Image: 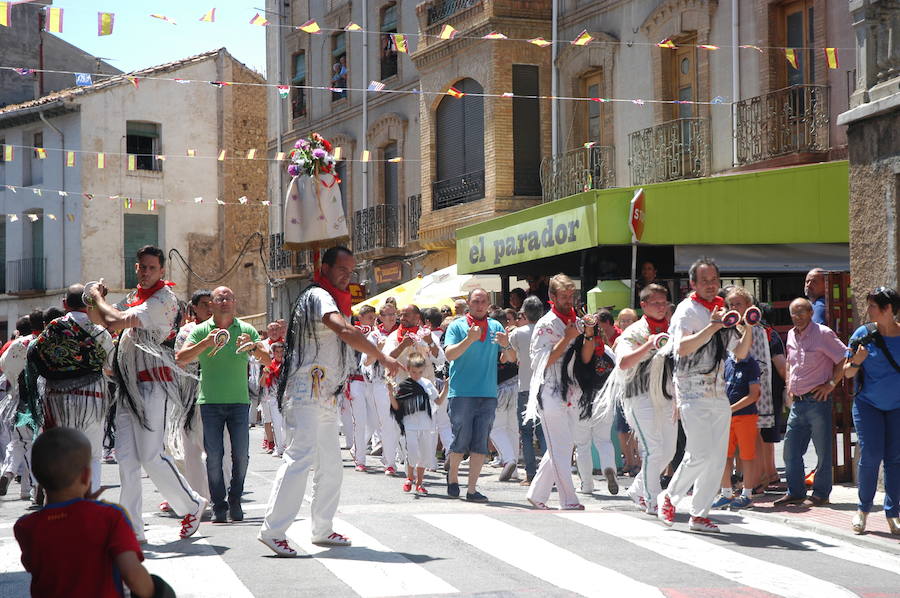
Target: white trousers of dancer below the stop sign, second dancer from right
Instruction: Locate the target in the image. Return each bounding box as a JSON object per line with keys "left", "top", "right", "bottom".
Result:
{"left": 625, "top": 395, "right": 678, "bottom": 512}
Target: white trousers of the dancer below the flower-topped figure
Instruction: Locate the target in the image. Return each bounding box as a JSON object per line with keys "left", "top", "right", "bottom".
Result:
{"left": 260, "top": 400, "right": 344, "bottom": 540}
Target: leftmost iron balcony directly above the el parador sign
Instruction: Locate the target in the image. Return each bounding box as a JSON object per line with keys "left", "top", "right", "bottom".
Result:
{"left": 541, "top": 145, "right": 616, "bottom": 202}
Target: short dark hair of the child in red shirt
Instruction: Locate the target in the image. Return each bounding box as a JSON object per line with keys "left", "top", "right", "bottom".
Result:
{"left": 31, "top": 428, "right": 91, "bottom": 492}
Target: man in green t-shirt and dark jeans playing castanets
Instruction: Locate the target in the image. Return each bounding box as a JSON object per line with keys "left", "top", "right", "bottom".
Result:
{"left": 176, "top": 287, "right": 271, "bottom": 523}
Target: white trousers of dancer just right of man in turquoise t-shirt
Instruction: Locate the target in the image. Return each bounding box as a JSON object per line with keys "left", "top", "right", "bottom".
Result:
{"left": 527, "top": 396, "right": 578, "bottom": 505}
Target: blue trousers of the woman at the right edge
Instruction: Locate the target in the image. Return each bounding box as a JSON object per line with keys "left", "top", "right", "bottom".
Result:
{"left": 853, "top": 400, "right": 900, "bottom": 517}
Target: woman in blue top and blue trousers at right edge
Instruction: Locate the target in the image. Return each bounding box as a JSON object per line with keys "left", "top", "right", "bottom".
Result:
{"left": 844, "top": 287, "right": 900, "bottom": 535}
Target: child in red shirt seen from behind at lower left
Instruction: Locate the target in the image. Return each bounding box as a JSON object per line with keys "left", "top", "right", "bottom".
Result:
{"left": 14, "top": 428, "right": 162, "bottom": 598}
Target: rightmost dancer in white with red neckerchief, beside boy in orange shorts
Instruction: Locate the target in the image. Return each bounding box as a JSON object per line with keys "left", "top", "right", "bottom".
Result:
{"left": 657, "top": 258, "right": 753, "bottom": 532}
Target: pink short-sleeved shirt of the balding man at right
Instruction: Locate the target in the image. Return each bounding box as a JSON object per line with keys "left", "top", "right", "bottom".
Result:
{"left": 786, "top": 322, "right": 847, "bottom": 396}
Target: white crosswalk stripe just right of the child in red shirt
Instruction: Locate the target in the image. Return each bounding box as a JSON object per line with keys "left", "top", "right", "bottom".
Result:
{"left": 143, "top": 526, "right": 253, "bottom": 598}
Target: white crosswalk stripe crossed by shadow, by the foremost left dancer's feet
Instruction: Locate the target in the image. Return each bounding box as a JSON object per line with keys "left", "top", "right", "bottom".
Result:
{"left": 288, "top": 519, "right": 459, "bottom": 598}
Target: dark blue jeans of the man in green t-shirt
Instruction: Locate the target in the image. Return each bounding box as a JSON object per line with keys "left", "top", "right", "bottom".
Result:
{"left": 200, "top": 403, "right": 250, "bottom": 514}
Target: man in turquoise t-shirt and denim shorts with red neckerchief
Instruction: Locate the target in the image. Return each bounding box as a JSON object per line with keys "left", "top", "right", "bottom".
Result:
{"left": 444, "top": 289, "right": 512, "bottom": 502}
